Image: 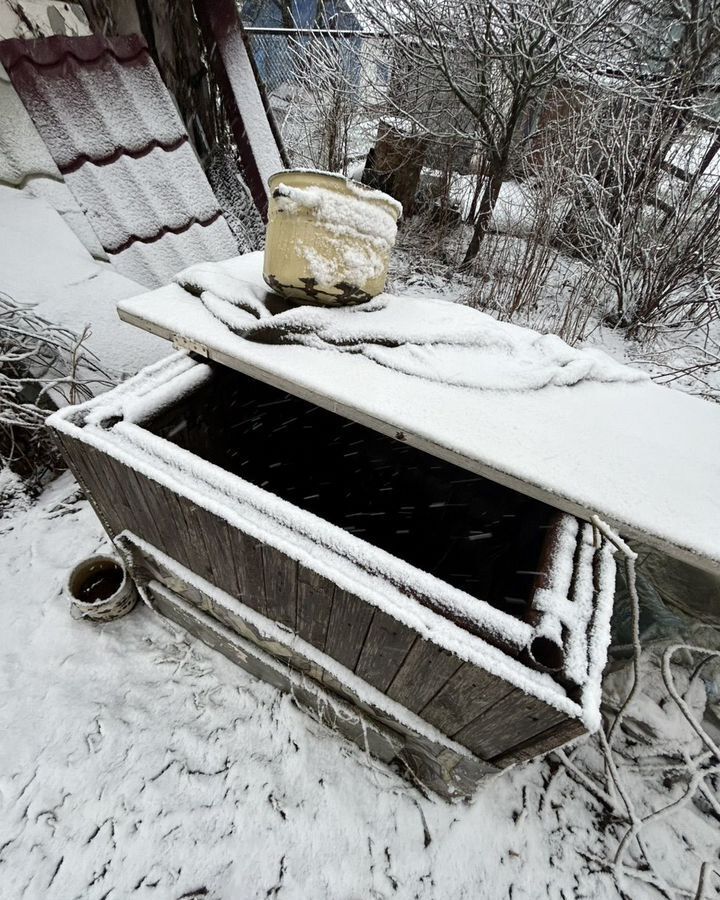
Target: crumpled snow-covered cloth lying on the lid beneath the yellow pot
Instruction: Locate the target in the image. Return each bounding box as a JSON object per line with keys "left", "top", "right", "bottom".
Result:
{"left": 175, "top": 256, "right": 648, "bottom": 391}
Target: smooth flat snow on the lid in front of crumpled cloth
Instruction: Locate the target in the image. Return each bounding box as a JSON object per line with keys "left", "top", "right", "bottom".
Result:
{"left": 118, "top": 253, "right": 720, "bottom": 571}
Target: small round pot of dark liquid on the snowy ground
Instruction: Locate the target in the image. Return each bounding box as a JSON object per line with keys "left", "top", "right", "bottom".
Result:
{"left": 65, "top": 556, "right": 138, "bottom": 622}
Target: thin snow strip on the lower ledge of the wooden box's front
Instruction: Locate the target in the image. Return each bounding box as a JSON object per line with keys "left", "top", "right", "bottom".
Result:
{"left": 125, "top": 531, "right": 496, "bottom": 765}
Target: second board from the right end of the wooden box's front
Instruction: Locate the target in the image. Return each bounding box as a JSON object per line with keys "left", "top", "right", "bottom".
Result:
{"left": 453, "top": 689, "right": 568, "bottom": 759}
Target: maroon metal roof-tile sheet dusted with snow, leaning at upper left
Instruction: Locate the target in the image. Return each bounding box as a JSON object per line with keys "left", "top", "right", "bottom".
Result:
{"left": 0, "top": 35, "right": 237, "bottom": 286}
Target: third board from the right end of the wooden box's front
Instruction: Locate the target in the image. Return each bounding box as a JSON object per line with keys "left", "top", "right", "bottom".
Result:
{"left": 420, "top": 663, "right": 512, "bottom": 736}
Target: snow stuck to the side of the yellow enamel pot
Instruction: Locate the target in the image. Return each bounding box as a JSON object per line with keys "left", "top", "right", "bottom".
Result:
{"left": 273, "top": 182, "right": 398, "bottom": 287}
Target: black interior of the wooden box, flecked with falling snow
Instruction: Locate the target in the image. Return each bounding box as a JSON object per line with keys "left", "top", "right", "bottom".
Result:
{"left": 144, "top": 367, "right": 555, "bottom": 617}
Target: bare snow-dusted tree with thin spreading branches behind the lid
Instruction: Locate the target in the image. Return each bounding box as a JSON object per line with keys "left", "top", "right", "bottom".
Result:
{"left": 372, "top": 0, "right": 618, "bottom": 265}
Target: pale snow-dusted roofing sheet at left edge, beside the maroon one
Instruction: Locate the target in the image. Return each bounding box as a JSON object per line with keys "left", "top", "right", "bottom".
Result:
{"left": 0, "top": 66, "right": 107, "bottom": 259}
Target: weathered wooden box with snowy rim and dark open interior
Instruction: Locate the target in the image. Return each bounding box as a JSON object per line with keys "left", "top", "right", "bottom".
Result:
{"left": 50, "top": 353, "right": 614, "bottom": 798}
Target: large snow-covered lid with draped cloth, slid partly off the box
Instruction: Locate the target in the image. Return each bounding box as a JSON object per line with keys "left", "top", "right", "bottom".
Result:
{"left": 118, "top": 253, "right": 720, "bottom": 571}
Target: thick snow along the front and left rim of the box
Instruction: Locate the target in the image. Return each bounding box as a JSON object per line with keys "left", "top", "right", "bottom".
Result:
{"left": 49, "top": 353, "right": 612, "bottom": 728}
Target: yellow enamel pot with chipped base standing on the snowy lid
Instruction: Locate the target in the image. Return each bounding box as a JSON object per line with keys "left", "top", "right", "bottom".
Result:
{"left": 263, "top": 170, "right": 402, "bottom": 306}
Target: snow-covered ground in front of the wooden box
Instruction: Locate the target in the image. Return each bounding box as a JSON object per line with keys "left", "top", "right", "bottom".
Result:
{"left": 0, "top": 475, "right": 720, "bottom": 900}
